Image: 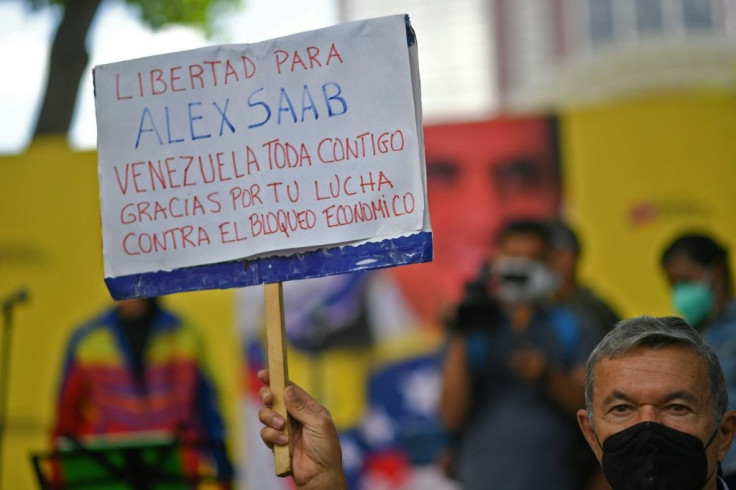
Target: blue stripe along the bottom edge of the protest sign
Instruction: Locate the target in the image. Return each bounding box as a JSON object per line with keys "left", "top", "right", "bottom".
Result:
{"left": 105, "top": 231, "right": 432, "bottom": 300}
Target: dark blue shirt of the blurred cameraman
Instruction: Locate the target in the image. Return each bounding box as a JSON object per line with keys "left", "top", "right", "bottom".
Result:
{"left": 457, "top": 308, "right": 599, "bottom": 490}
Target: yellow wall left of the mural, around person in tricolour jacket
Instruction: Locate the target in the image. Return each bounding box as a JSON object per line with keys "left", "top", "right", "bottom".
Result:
{"left": 0, "top": 138, "right": 240, "bottom": 489}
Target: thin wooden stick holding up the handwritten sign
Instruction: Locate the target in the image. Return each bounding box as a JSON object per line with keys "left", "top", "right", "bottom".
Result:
{"left": 264, "top": 282, "right": 291, "bottom": 476}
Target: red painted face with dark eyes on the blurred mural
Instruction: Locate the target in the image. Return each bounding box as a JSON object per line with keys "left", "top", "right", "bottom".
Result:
{"left": 393, "top": 118, "right": 560, "bottom": 323}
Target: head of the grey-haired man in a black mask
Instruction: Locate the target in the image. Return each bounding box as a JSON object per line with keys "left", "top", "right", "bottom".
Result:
{"left": 578, "top": 316, "right": 736, "bottom": 490}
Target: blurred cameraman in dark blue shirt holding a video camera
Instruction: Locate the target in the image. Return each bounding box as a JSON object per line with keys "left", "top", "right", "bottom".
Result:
{"left": 440, "top": 221, "right": 600, "bottom": 490}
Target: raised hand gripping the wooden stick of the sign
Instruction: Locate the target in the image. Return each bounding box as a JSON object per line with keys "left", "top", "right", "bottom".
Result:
{"left": 258, "top": 369, "right": 347, "bottom": 490}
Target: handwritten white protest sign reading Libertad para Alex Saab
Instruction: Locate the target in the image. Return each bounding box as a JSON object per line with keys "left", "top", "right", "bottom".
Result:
{"left": 94, "top": 16, "right": 431, "bottom": 299}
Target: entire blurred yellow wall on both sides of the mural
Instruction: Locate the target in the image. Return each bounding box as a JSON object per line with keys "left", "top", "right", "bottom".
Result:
{"left": 5, "top": 93, "right": 736, "bottom": 489}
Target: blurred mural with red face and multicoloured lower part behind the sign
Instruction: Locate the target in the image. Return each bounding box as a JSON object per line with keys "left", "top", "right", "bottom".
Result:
{"left": 244, "top": 116, "right": 560, "bottom": 490}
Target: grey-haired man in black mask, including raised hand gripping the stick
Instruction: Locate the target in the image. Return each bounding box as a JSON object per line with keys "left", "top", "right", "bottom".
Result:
{"left": 259, "top": 317, "right": 736, "bottom": 490}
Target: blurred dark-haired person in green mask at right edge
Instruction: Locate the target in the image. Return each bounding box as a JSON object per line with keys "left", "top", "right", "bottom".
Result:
{"left": 662, "top": 233, "right": 736, "bottom": 487}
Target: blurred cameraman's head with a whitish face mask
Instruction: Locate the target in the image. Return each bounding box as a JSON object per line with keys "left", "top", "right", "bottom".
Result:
{"left": 490, "top": 220, "right": 557, "bottom": 303}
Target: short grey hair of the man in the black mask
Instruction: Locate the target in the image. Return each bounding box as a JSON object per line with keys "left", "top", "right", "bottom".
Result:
{"left": 585, "top": 316, "right": 728, "bottom": 422}
